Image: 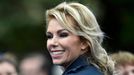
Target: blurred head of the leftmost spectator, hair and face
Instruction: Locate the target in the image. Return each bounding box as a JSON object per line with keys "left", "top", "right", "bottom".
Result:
{"left": 0, "top": 53, "right": 18, "bottom": 75}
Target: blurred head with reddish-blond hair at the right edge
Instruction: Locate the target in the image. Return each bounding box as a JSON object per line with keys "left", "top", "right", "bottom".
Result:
{"left": 111, "top": 51, "right": 134, "bottom": 75}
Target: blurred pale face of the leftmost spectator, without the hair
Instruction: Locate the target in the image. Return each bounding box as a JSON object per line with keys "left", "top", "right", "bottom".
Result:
{"left": 0, "top": 62, "right": 17, "bottom": 75}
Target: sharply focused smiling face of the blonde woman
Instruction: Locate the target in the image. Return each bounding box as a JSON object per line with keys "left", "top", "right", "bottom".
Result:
{"left": 46, "top": 19, "right": 85, "bottom": 67}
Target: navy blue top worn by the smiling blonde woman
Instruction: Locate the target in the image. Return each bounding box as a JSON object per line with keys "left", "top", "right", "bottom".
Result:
{"left": 62, "top": 56, "right": 103, "bottom": 75}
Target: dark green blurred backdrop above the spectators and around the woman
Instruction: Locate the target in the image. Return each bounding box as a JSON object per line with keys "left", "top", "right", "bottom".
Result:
{"left": 0, "top": 0, "right": 134, "bottom": 56}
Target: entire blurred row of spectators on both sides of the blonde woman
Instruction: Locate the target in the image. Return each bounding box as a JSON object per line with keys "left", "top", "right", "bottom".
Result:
{"left": 0, "top": 51, "right": 134, "bottom": 75}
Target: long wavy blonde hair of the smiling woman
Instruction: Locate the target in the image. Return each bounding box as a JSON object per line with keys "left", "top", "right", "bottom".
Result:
{"left": 46, "top": 2, "right": 114, "bottom": 75}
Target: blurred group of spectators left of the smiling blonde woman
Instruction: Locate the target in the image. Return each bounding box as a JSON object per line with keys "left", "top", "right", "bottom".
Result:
{"left": 0, "top": 52, "right": 62, "bottom": 75}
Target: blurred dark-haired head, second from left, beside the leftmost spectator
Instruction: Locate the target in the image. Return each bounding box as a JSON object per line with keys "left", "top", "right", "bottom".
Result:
{"left": 19, "top": 52, "right": 52, "bottom": 75}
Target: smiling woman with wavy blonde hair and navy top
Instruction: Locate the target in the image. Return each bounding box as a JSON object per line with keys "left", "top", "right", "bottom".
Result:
{"left": 46, "top": 2, "right": 114, "bottom": 75}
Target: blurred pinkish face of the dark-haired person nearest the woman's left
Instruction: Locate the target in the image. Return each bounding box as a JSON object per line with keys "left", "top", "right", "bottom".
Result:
{"left": 20, "top": 58, "right": 48, "bottom": 75}
